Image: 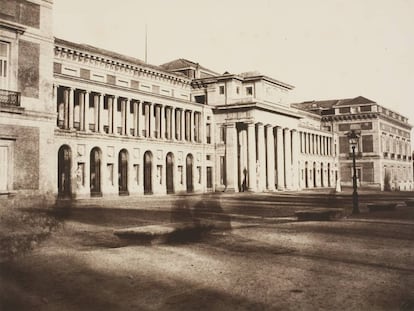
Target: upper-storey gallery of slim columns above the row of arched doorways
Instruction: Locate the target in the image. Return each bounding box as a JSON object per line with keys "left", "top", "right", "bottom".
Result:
{"left": 54, "top": 86, "right": 206, "bottom": 143}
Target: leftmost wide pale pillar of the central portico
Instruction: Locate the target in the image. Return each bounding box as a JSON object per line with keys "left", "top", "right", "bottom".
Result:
{"left": 226, "top": 123, "right": 238, "bottom": 192}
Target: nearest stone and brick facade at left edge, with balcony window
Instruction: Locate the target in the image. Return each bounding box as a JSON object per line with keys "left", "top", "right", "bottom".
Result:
{"left": 0, "top": 0, "right": 56, "bottom": 206}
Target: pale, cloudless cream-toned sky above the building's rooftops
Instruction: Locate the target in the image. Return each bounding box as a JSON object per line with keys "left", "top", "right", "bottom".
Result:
{"left": 54, "top": 0, "right": 414, "bottom": 146}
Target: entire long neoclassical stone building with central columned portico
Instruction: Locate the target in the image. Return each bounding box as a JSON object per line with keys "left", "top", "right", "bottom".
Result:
{"left": 0, "top": 0, "right": 412, "bottom": 210}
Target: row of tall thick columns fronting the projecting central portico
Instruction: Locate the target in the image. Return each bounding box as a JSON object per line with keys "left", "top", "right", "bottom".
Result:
{"left": 225, "top": 122, "right": 299, "bottom": 192}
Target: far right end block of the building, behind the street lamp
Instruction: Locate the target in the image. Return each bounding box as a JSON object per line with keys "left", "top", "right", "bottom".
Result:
{"left": 292, "top": 96, "right": 414, "bottom": 191}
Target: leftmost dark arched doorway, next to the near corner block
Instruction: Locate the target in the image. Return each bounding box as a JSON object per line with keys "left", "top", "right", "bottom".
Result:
{"left": 58, "top": 146, "right": 72, "bottom": 198}
